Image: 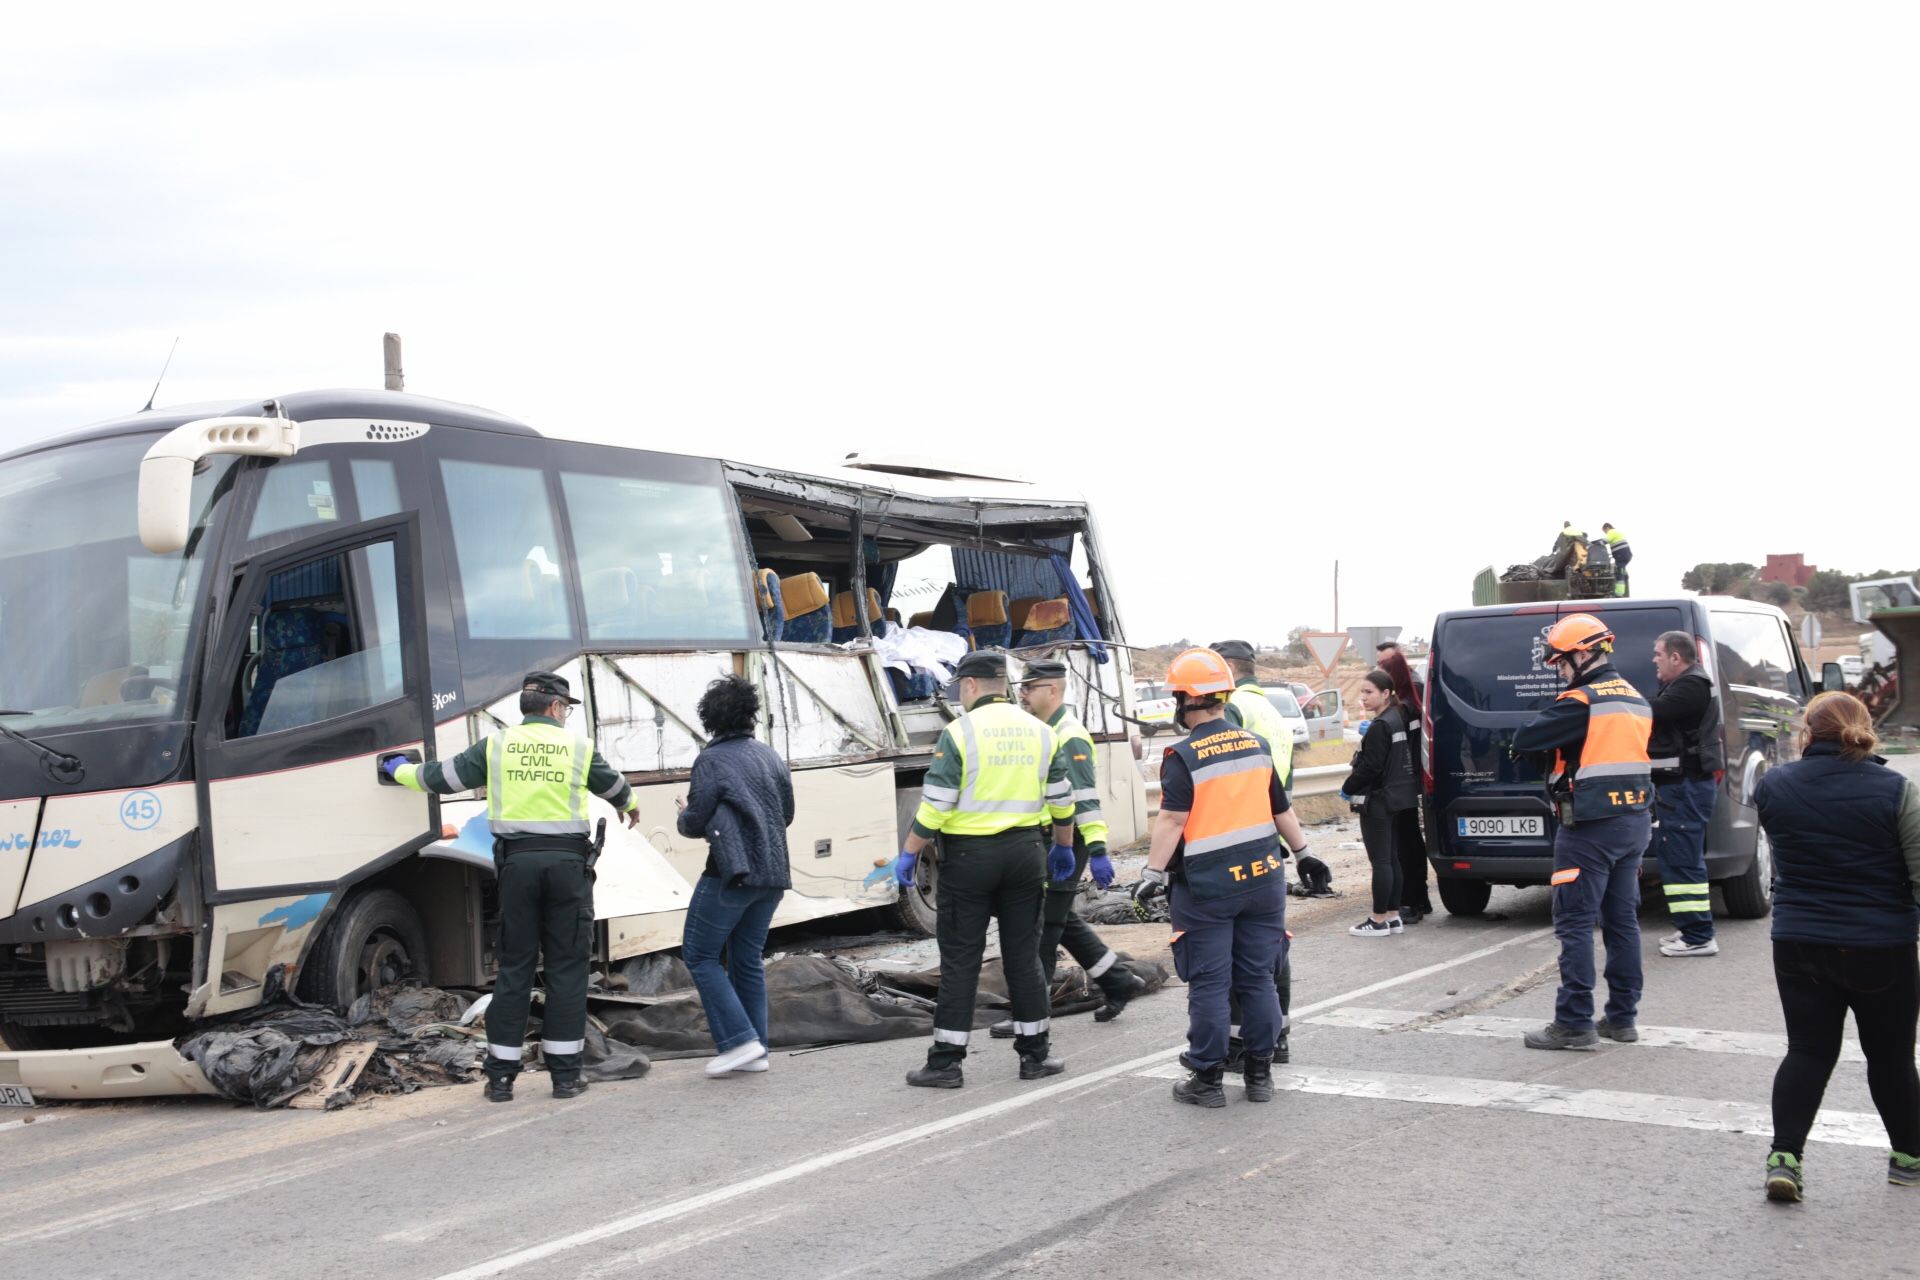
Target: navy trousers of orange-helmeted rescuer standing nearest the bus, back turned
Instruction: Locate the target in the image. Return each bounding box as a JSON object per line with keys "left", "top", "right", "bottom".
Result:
{"left": 1169, "top": 875, "right": 1286, "bottom": 1071}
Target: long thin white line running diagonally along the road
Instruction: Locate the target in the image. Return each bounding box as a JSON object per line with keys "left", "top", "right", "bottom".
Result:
{"left": 438, "top": 929, "right": 1553, "bottom": 1280}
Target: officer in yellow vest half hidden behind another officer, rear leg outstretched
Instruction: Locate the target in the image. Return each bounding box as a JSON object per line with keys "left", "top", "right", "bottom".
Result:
{"left": 983, "top": 658, "right": 1146, "bottom": 1040}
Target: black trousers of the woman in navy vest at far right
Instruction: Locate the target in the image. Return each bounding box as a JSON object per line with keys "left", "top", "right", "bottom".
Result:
{"left": 1774, "top": 940, "right": 1920, "bottom": 1157}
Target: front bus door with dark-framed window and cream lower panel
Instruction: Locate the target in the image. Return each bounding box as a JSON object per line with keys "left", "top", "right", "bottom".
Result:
{"left": 188, "top": 514, "right": 440, "bottom": 1015}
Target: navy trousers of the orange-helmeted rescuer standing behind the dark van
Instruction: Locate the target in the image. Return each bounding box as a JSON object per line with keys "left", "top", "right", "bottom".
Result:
{"left": 1553, "top": 814, "right": 1653, "bottom": 1031}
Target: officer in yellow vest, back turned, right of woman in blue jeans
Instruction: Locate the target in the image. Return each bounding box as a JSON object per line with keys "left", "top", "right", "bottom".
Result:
{"left": 893, "top": 651, "right": 1075, "bottom": 1088}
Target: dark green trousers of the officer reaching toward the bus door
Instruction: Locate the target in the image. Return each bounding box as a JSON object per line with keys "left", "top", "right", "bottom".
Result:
{"left": 486, "top": 841, "right": 593, "bottom": 1082}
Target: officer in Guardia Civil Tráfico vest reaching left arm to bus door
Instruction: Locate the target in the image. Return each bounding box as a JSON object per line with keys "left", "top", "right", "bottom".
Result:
{"left": 380, "top": 672, "right": 639, "bottom": 1102}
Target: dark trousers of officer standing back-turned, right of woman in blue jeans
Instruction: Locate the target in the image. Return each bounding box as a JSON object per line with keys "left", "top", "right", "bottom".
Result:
{"left": 927, "top": 827, "right": 1050, "bottom": 1067}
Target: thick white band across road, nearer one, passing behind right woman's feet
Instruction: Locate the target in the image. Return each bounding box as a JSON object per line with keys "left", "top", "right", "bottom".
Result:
{"left": 1140, "top": 1063, "right": 1887, "bottom": 1150}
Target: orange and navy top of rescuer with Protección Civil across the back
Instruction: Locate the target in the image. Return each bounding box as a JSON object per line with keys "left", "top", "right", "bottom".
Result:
{"left": 1160, "top": 720, "right": 1290, "bottom": 898}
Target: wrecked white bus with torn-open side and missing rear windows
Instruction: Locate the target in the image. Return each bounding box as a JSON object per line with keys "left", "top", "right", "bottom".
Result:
{"left": 0, "top": 391, "right": 1146, "bottom": 1098}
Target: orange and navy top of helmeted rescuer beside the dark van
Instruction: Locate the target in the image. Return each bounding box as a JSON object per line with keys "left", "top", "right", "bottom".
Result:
{"left": 1513, "top": 662, "right": 1653, "bottom": 821}
